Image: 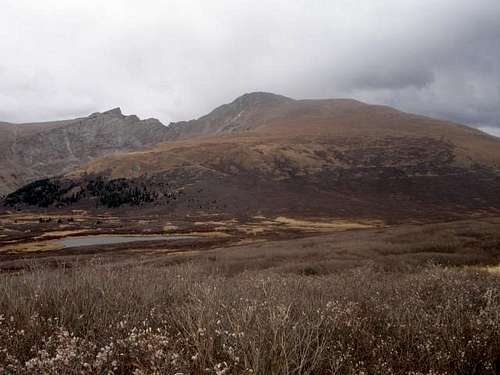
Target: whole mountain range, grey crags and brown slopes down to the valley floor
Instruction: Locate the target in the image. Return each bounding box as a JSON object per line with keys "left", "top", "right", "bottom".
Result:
{"left": 0, "top": 93, "right": 500, "bottom": 218}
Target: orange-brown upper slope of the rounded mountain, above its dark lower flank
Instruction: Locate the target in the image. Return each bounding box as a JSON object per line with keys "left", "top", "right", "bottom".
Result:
{"left": 74, "top": 93, "right": 500, "bottom": 178}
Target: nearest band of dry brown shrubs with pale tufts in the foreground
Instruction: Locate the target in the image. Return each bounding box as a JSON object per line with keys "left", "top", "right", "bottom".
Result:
{"left": 0, "top": 260, "right": 500, "bottom": 375}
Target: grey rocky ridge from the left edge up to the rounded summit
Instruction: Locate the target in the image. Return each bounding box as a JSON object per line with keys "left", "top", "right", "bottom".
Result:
{"left": 0, "top": 93, "right": 292, "bottom": 195}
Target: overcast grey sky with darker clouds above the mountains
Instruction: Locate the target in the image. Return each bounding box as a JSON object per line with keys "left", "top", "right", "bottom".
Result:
{"left": 0, "top": 0, "right": 500, "bottom": 135}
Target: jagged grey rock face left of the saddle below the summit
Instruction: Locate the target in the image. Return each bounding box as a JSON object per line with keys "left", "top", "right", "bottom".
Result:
{"left": 0, "top": 108, "right": 169, "bottom": 194}
